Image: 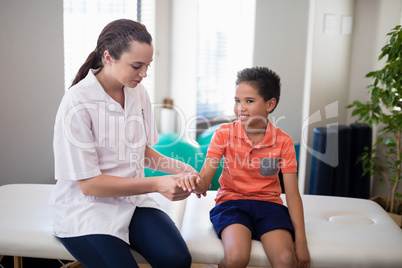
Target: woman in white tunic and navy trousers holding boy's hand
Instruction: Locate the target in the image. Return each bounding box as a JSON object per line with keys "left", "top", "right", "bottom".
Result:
{"left": 50, "top": 20, "right": 198, "bottom": 268}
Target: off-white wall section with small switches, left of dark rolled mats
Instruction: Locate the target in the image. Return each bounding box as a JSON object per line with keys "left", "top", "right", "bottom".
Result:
{"left": 299, "top": 0, "right": 354, "bottom": 192}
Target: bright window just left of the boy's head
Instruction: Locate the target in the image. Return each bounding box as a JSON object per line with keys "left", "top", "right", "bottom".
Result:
{"left": 196, "top": 0, "right": 255, "bottom": 118}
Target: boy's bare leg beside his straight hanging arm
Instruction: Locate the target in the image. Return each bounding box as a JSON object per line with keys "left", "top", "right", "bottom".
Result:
{"left": 260, "top": 229, "right": 297, "bottom": 267}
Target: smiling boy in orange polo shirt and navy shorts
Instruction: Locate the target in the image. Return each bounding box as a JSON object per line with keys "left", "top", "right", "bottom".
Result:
{"left": 179, "top": 67, "right": 310, "bottom": 268}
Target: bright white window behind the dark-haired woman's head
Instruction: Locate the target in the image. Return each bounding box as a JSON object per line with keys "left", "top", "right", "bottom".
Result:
{"left": 63, "top": 0, "right": 155, "bottom": 101}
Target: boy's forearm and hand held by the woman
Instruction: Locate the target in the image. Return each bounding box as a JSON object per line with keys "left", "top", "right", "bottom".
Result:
{"left": 178, "top": 157, "right": 220, "bottom": 196}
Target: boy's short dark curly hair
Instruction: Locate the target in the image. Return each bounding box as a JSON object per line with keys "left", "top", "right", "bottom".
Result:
{"left": 236, "top": 67, "right": 281, "bottom": 111}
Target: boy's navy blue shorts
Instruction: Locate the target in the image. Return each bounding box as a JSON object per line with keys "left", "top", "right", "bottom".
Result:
{"left": 209, "top": 200, "right": 295, "bottom": 241}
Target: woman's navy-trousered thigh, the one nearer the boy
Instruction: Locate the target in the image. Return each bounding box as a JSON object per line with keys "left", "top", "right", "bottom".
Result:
{"left": 129, "top": 207, "right": 191, "bottom": 268}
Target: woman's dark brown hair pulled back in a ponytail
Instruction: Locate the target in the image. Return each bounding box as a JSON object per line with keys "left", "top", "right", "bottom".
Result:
{"left": 71, "top": 19, "right": 152, "bottom": 86}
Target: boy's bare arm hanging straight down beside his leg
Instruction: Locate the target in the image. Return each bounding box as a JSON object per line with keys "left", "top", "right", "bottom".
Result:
{"left": 283, "top": 173, "right": 310, "bottom": 267}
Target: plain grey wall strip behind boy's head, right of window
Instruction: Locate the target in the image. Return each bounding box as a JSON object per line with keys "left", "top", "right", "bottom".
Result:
{"left": 253, "top": 0, "right": 309, "bottom": 143}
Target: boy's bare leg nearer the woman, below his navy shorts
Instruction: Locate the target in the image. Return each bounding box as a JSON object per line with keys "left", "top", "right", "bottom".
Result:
{"left": 219, "top": 223, "right": 251, "bottom": 268}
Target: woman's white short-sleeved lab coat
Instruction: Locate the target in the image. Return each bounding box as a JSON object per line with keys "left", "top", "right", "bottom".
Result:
{"left": 49, "top": 70, "right": 159, "bottom": 243}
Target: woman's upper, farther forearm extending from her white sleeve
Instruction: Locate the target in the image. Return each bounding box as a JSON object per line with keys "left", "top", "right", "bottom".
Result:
{"left": 144, "top": 146, "right": 198, "bottom": 174}
